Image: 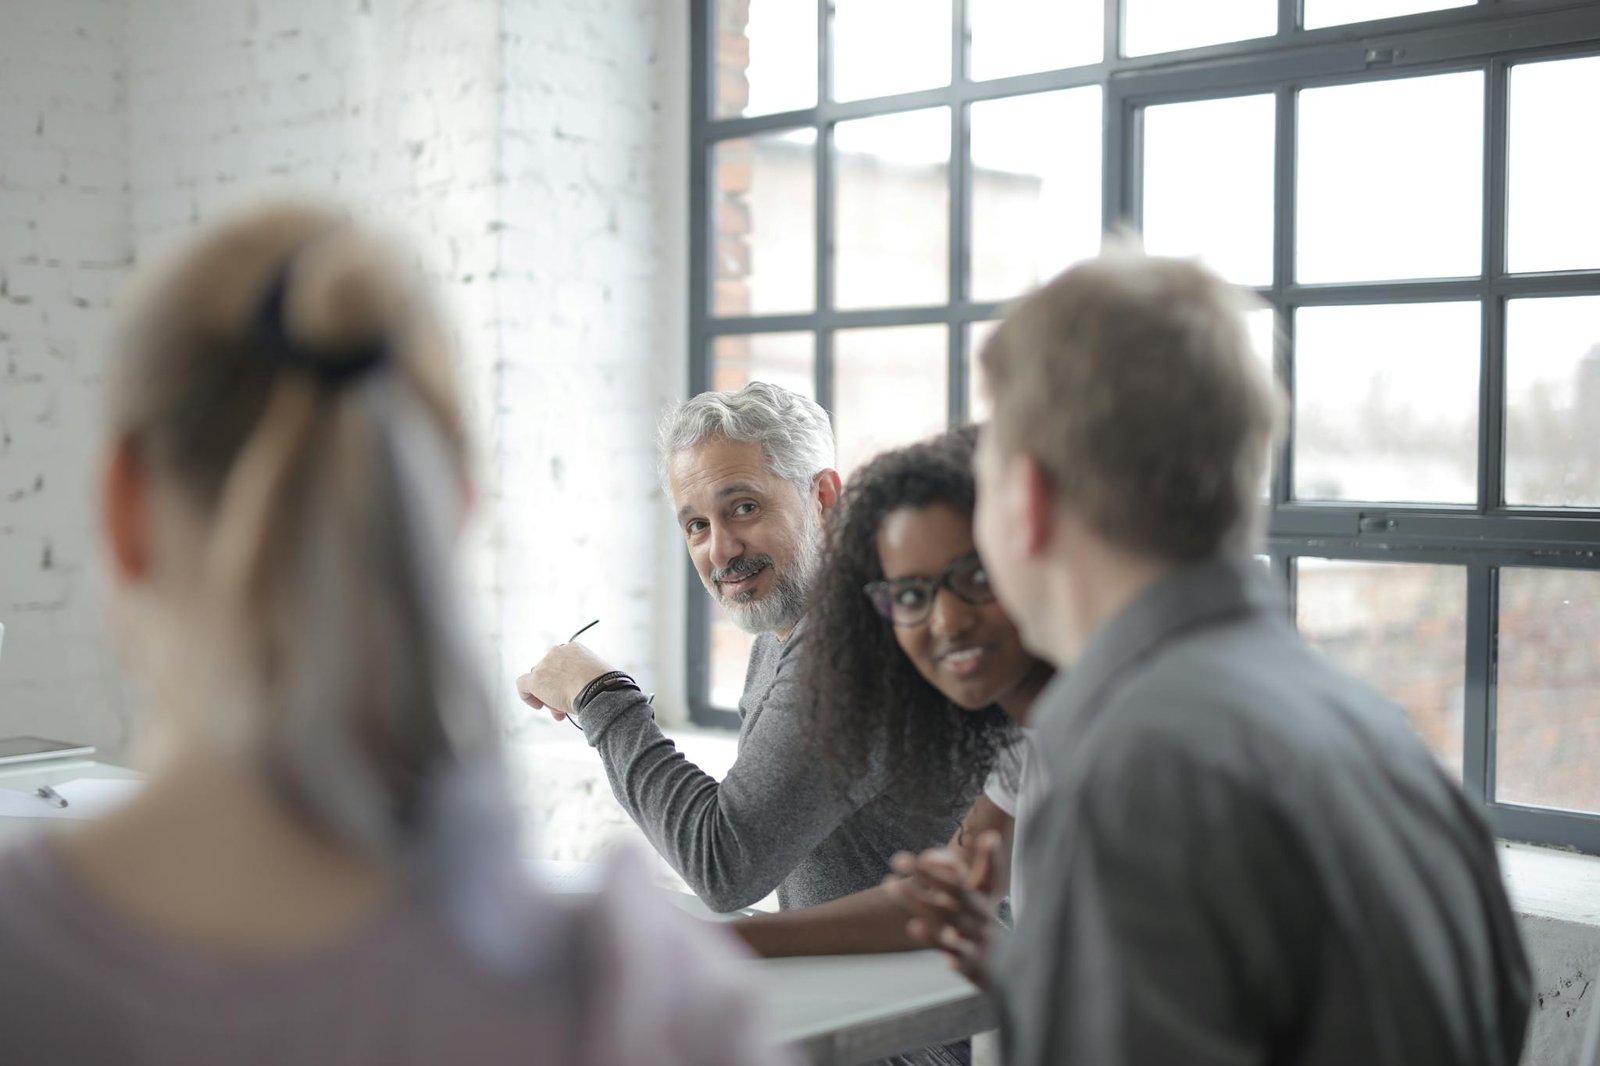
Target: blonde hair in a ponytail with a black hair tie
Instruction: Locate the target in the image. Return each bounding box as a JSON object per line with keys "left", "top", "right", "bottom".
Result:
{"left": 114, "top": 208, "right": 518, "bottom": 951}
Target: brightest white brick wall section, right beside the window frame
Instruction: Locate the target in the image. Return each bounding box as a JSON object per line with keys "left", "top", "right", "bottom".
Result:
{"left": 498, "top": 0, "right": 691, "bottom": 860}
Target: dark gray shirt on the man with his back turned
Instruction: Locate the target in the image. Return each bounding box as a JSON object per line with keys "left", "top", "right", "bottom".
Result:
{"left": 992, "top": 559, "right": 1530, "bottom": 1066}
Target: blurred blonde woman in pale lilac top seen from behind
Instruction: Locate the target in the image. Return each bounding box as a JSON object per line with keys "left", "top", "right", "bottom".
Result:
{"left": 0, "top": 206, "right": 771, "bottom": 1066}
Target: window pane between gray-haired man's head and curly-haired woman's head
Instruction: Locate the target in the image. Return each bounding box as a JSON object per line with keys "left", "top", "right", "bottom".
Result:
{"left": 834, "top": 325, "right": 949, "bottom": 475}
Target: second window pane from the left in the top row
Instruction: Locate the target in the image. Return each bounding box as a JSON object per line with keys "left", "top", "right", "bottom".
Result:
{"left": 834, "top": 0, "right": 954, "bottom": 99}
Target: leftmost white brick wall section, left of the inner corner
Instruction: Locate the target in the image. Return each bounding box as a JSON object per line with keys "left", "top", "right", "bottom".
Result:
{"left": 0, "top": 0, "right": 131, "bottom": 749}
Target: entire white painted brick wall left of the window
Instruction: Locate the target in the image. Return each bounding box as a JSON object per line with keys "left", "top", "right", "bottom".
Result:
{"left": 0, "top": 0, "right": 686, "bottom": 855}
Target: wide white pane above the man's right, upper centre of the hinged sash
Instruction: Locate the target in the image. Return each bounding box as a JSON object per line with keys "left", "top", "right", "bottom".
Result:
{"left": 1296, "top": 70, "right": 1483, "bottom": 283}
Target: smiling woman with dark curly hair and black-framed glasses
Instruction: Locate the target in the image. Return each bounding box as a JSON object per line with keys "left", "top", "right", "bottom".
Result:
{"left": 734, "top": 427, "right": 1051, "bottom": 957}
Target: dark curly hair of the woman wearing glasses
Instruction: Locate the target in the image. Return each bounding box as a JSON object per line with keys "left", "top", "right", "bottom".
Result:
{"left": 800, "top": 426, "right": 1016, "bottom": 807}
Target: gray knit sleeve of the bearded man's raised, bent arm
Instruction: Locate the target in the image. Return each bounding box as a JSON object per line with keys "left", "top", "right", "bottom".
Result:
{"left": 581, "top": 679, "right": 870, "bottom": 912}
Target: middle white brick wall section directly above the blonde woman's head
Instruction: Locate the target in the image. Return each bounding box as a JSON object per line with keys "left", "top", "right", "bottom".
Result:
{"left": 128, "top": 0, "right": 499, "bottom": 704}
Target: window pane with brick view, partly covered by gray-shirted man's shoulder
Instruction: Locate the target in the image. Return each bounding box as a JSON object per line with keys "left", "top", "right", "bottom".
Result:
{"left": 1294, "top": 559, "right": 1467, "bottom": 779}
